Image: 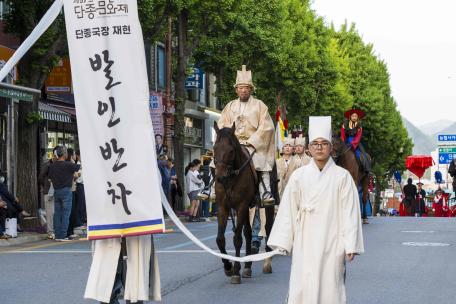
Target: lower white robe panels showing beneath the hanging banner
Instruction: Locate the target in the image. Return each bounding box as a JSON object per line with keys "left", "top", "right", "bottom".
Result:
{"left": 84, "top": 235, "right": 161, "bottom": 303}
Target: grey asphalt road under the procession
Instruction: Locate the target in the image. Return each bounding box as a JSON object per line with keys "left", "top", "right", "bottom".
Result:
{"left": 0, "top": 217, "right": 456, "bottom": 304}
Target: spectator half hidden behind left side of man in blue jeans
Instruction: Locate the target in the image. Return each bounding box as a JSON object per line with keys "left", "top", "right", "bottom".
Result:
{"left": 38, "top": 147, "right": 57, "bottom": 239}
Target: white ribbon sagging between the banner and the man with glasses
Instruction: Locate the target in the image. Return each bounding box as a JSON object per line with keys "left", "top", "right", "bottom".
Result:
{"left": 157, "top": 188, "right": 283, "bottom": 263}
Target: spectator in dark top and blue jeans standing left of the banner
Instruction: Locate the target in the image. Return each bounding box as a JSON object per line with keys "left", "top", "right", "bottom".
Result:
{"left": 48, "top": 146, "right": 80, "bottom": 242}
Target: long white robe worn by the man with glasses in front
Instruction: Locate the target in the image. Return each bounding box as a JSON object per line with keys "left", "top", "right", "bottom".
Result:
{"left": 268, "top": 158, "right": 364, "bottom": 304}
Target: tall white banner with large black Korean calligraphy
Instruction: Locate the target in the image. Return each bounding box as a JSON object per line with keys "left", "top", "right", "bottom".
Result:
{"left": 64, "top": 0, "right": 165, "bottom": 240}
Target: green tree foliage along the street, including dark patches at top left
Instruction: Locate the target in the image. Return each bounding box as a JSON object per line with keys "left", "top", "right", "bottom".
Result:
{"left": 3, "top": 0, "right": 412, "bottom": 209}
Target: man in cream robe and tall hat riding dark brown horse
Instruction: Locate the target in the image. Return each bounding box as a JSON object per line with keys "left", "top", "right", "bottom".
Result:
{"left": 210, "top": 66, "right": 278, "bottom": 284}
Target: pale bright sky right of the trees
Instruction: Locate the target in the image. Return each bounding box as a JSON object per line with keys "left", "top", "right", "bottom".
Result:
{"left": 312, "top": 0, "right": 456, "bottom": 126}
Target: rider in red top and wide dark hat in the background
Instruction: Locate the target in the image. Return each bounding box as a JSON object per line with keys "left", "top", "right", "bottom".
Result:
{"left": 340, "top": 109, "right": 371, "bottom": 173}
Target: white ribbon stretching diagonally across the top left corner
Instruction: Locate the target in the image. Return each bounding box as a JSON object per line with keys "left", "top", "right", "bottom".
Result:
{"left": 0, "top": 0, "right": 63, "bottom": 81}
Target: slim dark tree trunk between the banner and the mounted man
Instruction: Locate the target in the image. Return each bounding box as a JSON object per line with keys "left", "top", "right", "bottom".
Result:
{"left": 174, "top": 10, "right": 188, "bottom": 211}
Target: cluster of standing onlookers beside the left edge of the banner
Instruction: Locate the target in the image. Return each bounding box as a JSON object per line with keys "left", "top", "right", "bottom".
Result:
{"left": 38, "top": 146, "right": 87, "bottom": 241}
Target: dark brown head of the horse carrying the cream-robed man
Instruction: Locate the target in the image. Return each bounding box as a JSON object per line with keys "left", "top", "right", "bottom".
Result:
{"left": 214, "top": 122, "right": 240, "bottom": 182}
